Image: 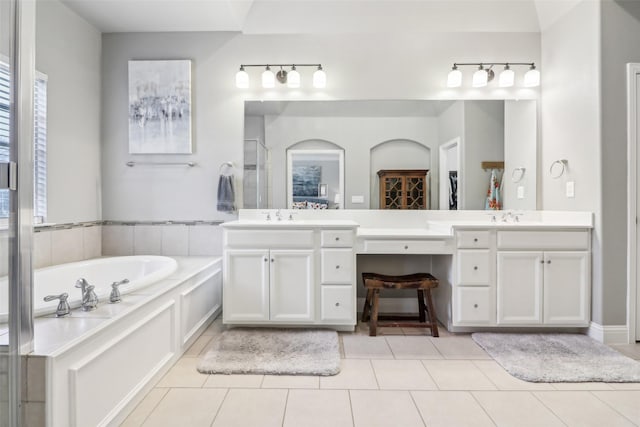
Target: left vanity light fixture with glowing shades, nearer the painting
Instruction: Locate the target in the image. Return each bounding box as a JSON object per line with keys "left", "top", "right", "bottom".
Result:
{"left": 236, "top": 64, "right": 327, "bottom": 89}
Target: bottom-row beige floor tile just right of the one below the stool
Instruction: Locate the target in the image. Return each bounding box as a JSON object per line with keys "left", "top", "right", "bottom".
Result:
{"left": 411, "top": 391, "right": 495, "bottom": 427}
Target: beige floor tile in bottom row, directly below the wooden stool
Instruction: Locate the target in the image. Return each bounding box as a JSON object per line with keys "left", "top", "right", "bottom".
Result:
{"left": 349, "top": 390, "right": 424, "bottom": 427}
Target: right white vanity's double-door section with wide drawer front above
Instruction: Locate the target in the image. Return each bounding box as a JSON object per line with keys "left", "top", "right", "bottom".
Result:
{"left": 497, "top": 230, "right": 590, "bottom": 326}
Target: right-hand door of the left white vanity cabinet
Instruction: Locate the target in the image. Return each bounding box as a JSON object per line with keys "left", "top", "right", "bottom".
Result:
{"left": 269, "top": 250, "right": 314, "bottom": 322}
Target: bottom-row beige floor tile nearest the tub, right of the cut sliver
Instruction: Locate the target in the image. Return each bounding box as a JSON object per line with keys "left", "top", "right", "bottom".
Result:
{"left": 142, "top": 388, "right": 227, "bottom": 427}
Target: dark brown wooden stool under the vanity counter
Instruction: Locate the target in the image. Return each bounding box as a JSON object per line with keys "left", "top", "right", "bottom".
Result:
{"left": 362, "top": 273, "right": 438, "bottom": 337}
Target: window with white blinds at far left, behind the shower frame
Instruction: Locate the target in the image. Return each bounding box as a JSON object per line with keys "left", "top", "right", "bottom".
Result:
{"left": 0, "top": 62, "right": 47, "bottom": 222}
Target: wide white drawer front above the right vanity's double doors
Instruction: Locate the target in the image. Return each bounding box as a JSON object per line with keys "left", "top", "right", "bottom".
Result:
{"left": 498, "top": 231, "right": 589, "bottom": 250}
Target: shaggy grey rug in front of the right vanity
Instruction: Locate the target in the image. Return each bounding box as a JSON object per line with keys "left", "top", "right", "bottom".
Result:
{"left": 471, "top": 332, "right": 640, "bottom": 383}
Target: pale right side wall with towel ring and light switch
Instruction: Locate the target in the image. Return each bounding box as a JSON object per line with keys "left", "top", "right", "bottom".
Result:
{"left": 539, "top": 0, "right": 604, "bottom": 324}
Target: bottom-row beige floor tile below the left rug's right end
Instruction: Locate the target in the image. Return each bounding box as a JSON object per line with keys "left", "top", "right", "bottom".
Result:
{"left": 284, "top": 390, "right": 353, "bottom": 427}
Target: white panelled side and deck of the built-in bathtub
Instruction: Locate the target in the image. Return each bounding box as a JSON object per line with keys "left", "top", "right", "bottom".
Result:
{"left": 0, "top": 257, "right": 222, "bottom": 427}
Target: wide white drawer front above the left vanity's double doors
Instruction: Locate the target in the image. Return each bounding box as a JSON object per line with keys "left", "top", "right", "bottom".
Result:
{"left": 225, "top": 230, "right": 314, "bottom": 249}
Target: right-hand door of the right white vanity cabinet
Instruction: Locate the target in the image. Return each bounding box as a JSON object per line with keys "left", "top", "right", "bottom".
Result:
{"left": 544, "top": 252, "right": 590, "bottom": 326}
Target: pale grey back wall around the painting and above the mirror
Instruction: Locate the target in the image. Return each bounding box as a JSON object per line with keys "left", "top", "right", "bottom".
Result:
{"left": 102, "top": 33, "right": 540, "bottom": 220}
